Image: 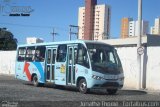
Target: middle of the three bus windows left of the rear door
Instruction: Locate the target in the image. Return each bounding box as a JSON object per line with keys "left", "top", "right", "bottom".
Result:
{"left": 26, "top": 47, "right": 35, "bottom": 61}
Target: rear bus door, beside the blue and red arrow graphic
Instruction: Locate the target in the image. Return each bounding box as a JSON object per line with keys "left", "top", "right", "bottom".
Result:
{"left": 45, "top": 47, "right": 57, "bottom": 82}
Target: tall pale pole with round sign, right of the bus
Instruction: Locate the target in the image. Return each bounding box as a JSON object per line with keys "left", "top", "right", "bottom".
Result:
{"left": 137, "top": 0, "right": 142, "bottom": 89}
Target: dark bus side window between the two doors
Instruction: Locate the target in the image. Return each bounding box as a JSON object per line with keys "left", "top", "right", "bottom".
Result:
{"left": 57, "top": 45, "right": 67, "bottom": 62}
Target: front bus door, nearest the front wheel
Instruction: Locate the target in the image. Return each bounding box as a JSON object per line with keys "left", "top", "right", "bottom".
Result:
{"left": 66, "top": 45, "right": 77, "bottom": 85}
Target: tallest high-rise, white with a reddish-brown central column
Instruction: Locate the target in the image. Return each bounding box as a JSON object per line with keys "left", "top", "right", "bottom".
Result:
{"left": 78, "top": 0, "right": 111, "bottom": 40}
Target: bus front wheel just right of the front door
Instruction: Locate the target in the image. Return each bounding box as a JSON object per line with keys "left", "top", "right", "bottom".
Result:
{"left": 78, "top": 79, "right": 87, "bottom": 94}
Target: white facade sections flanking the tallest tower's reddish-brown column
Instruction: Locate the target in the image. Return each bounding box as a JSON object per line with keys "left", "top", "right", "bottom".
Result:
{"left": 78, "top": 4, "right": 111, "bottom": 40}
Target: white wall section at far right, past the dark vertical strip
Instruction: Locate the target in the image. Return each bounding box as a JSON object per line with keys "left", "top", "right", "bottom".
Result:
{"left": 146, "top": 47, "right": 160, "bottom": 90}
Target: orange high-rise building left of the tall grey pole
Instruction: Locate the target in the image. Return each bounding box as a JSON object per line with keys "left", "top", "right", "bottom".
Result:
{"left": 121, "top": 17, "right": 133, "bottom": 38}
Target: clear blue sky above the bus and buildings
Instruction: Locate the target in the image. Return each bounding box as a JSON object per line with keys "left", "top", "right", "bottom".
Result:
{"left": 0, "top": 0, "right": 160, "bottom": 44}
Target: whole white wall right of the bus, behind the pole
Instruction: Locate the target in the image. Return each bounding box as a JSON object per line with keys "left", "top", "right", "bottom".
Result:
{"left": 117, "top": 46, "right": 160, "bottom": 90}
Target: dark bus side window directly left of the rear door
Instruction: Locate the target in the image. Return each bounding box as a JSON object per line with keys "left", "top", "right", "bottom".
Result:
{"left": 34, "top": 46, "right": 46, "bottom": 62}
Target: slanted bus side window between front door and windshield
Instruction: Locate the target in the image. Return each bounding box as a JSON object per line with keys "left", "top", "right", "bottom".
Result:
{"left": 77, "top": 44, "right": 89, "bottom": 68}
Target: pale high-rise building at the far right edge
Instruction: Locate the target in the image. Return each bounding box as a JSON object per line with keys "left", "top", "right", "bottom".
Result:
{"left": 150, "top": 18, "right": 160, "bottom": 35}
